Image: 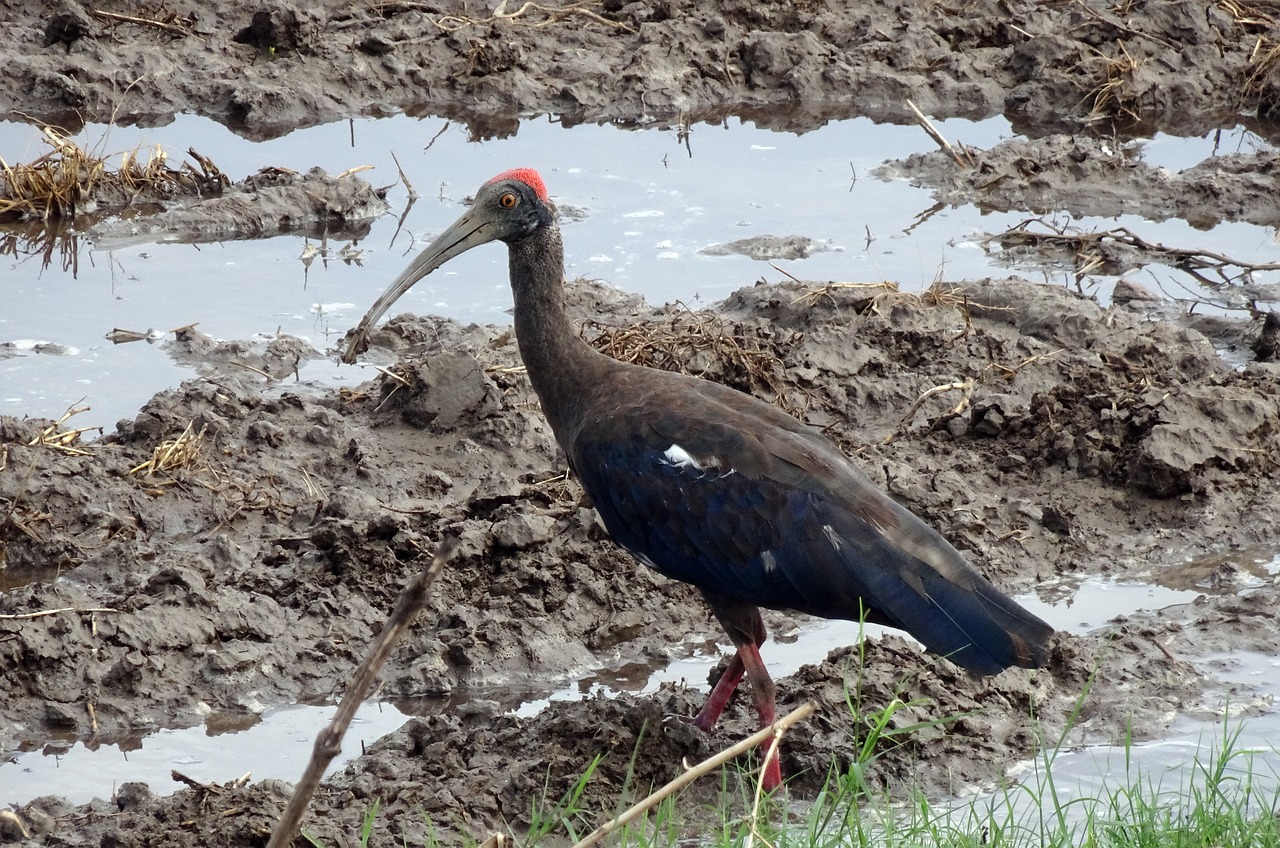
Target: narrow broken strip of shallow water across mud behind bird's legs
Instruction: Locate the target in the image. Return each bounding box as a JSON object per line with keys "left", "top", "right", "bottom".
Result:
{"left": 0, "top": 556, "right": 1280, "bottom": 815}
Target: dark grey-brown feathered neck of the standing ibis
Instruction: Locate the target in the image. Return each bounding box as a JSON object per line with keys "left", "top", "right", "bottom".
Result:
{"left": 509, "top": 225, "right": 617, "bottom": 451}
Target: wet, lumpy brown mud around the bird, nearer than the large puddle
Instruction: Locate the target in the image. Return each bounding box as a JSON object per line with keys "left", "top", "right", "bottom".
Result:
{"left": 0, "top": 279, "right": 1280, "bottom": 844}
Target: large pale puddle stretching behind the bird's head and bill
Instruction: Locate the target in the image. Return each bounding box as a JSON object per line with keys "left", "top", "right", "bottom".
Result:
{"left": 0, "top": 115, "right": 1275, "bottom": 428}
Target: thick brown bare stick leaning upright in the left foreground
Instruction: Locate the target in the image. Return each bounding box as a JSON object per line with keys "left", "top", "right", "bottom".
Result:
{"left": 266, "top": 537, "right": 458, "bottom": 848}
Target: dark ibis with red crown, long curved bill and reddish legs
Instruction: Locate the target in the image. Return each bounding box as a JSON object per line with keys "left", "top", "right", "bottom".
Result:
{"left": 343, "top": 168, "right": 1053, "bottom": 792}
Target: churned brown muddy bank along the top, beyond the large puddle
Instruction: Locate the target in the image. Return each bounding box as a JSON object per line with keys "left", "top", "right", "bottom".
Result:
{"left": 0, "top": 0, "right": 1280, "bottom": 138}
